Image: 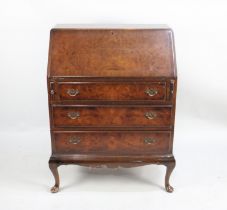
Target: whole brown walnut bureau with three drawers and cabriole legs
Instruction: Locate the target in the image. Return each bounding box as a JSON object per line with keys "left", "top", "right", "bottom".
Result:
{"left": 47, "top": 25, "right": 177, "bottom": 192}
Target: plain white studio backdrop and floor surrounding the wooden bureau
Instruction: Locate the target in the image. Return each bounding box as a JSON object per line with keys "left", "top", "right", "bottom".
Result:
{"left": 0, "top": 0, "right": 227, "bottom": 210}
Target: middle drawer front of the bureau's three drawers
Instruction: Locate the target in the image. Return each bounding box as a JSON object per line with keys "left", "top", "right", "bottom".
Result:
{"left": 52, "top": 105, "right": 171, "bottom": 127}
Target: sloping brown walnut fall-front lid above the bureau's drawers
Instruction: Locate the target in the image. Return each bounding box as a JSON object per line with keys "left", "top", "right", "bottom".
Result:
{"left": 48, "top": 28, "right": 176, "bottom": 77}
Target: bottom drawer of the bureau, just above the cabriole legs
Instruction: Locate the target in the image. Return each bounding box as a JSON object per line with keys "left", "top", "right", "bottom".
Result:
{"left": 53, "top": 131, "right": 172, "bottom": 155}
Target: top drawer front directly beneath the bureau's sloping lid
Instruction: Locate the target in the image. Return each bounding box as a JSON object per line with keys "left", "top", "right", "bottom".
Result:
{"left": 57, "top": 82, "right": 166, "bottom": 101}
